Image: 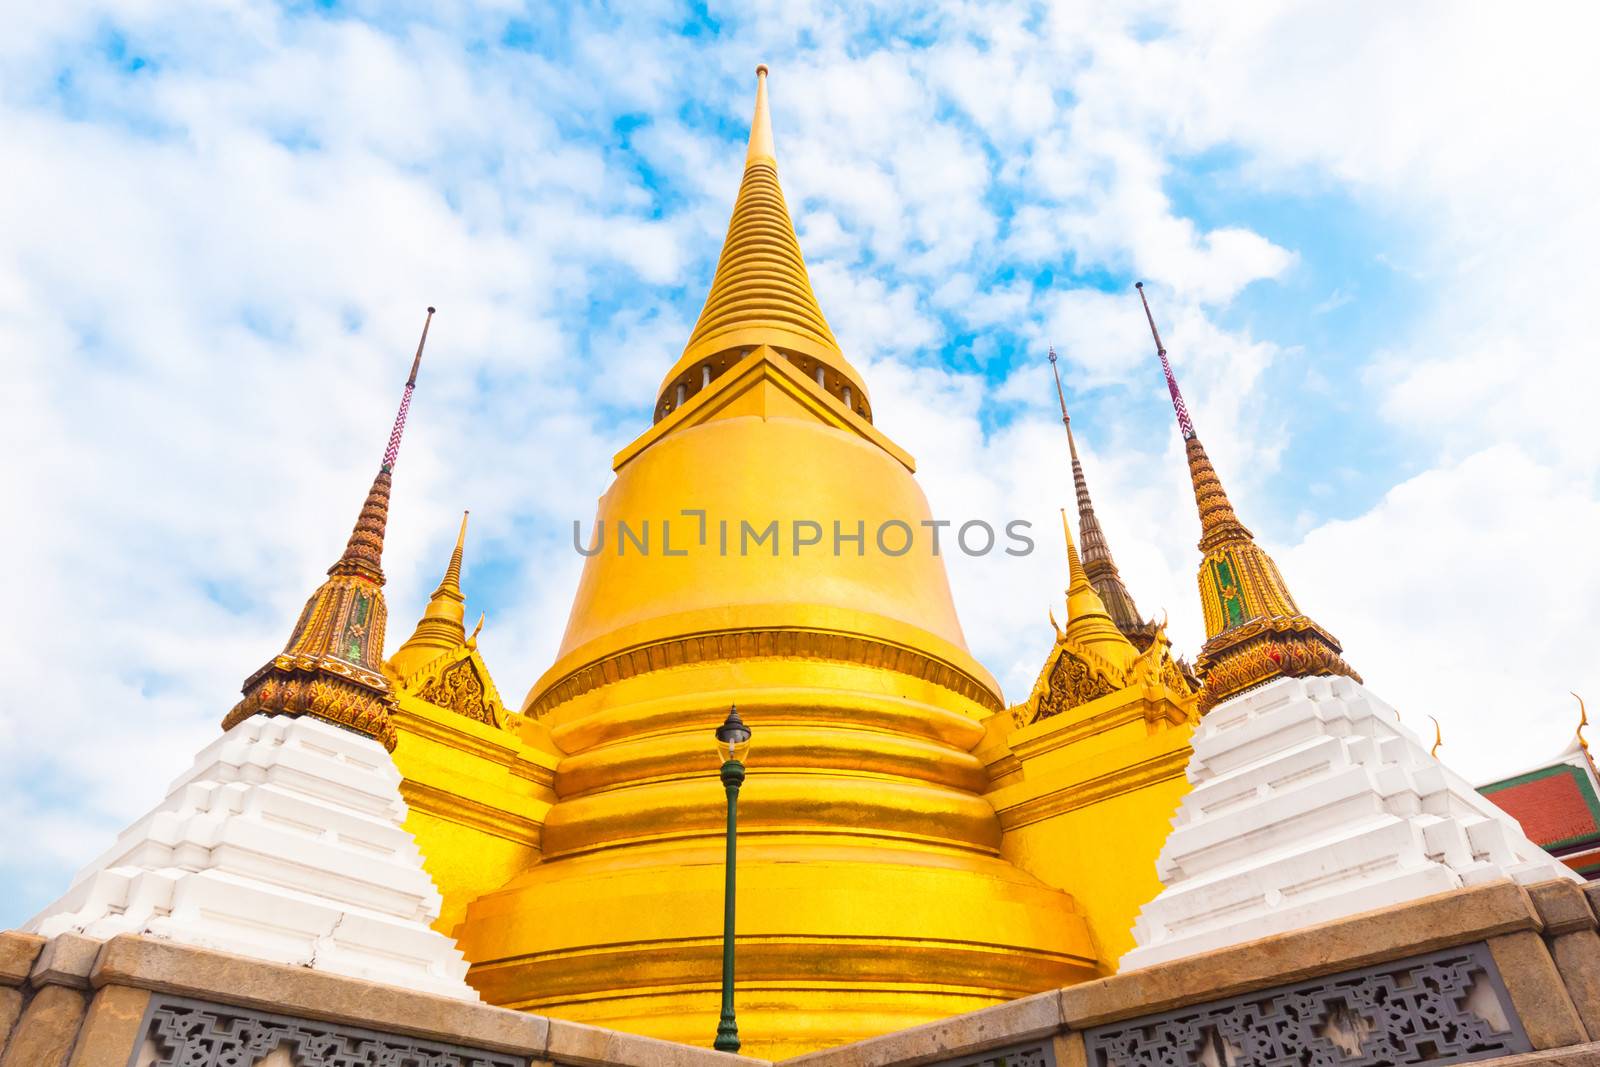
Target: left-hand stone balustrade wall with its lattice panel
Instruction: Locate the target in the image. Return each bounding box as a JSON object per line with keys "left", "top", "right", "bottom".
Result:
{"left": 0, "top": 933, "right": 763, "bottom": 1067}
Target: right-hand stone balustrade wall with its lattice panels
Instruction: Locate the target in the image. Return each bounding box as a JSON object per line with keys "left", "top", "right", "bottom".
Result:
{"left": 784, "top": 881, "right": 1600, "bottom": 1067}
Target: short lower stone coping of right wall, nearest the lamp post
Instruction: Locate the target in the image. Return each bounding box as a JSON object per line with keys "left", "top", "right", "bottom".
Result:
{"left": 781, "top": 990, "right": 1062, "bottom": 1067}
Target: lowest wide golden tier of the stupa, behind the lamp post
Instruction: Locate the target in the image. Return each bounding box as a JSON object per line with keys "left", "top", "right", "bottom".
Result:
{"left": 461, "top": 835, "right": 1099, "bottom": 1057}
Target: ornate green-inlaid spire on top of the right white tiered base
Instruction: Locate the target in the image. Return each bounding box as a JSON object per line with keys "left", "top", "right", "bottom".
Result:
{"left": 1138, "top": 282, "right": 1362, "bottom": 715}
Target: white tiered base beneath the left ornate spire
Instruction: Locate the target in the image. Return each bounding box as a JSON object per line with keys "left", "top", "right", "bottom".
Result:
{"left": 26, "top": 715, "right": 477, "bottom": 1000}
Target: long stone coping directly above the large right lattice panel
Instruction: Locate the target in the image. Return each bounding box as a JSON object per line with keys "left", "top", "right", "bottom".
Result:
{"left": 1061, "top": 880, "right": 1542, "bottom": 1030}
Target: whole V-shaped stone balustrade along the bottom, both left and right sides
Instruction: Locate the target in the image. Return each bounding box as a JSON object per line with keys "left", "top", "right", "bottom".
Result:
{"left": 9, "top": 881, "right": 1600, "bottom": 1067}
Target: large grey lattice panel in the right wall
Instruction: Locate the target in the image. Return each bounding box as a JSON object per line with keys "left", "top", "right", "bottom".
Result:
{"left": 1085, "top": 944, "right": 1533, "bottom": 1067}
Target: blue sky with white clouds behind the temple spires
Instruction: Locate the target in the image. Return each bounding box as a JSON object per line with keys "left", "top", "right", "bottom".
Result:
{"left": 9, "top": 0, "right": 1600, "bottom": 923}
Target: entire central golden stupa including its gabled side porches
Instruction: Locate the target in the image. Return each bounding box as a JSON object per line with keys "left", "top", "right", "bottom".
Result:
{"left": 374, "top": 67, "right": 1195, "bottom": 1056}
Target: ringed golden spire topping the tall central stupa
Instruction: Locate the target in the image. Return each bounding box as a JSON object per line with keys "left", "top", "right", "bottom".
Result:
{"left": 656, "top": 64, "right": 867, "bottom": 419}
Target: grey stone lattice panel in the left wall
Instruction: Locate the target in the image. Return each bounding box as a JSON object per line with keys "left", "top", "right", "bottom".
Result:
{"left": 128, "top": 997, "right": 528, "bottom": 1067}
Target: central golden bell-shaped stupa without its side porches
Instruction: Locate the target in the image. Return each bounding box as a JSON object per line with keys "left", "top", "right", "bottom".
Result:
{"left": 456, "top": 70, "right": 1094, "bottom": 1059}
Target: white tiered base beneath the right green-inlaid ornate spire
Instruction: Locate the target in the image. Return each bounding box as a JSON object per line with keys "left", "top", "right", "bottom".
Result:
{"left": 1120, "top": 677, "right": 1579, "bottom": 971}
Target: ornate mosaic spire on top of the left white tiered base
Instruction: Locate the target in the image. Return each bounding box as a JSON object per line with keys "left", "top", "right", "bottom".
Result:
{"left": 222, "top": 307, "right": 434, "bottom": 752}
